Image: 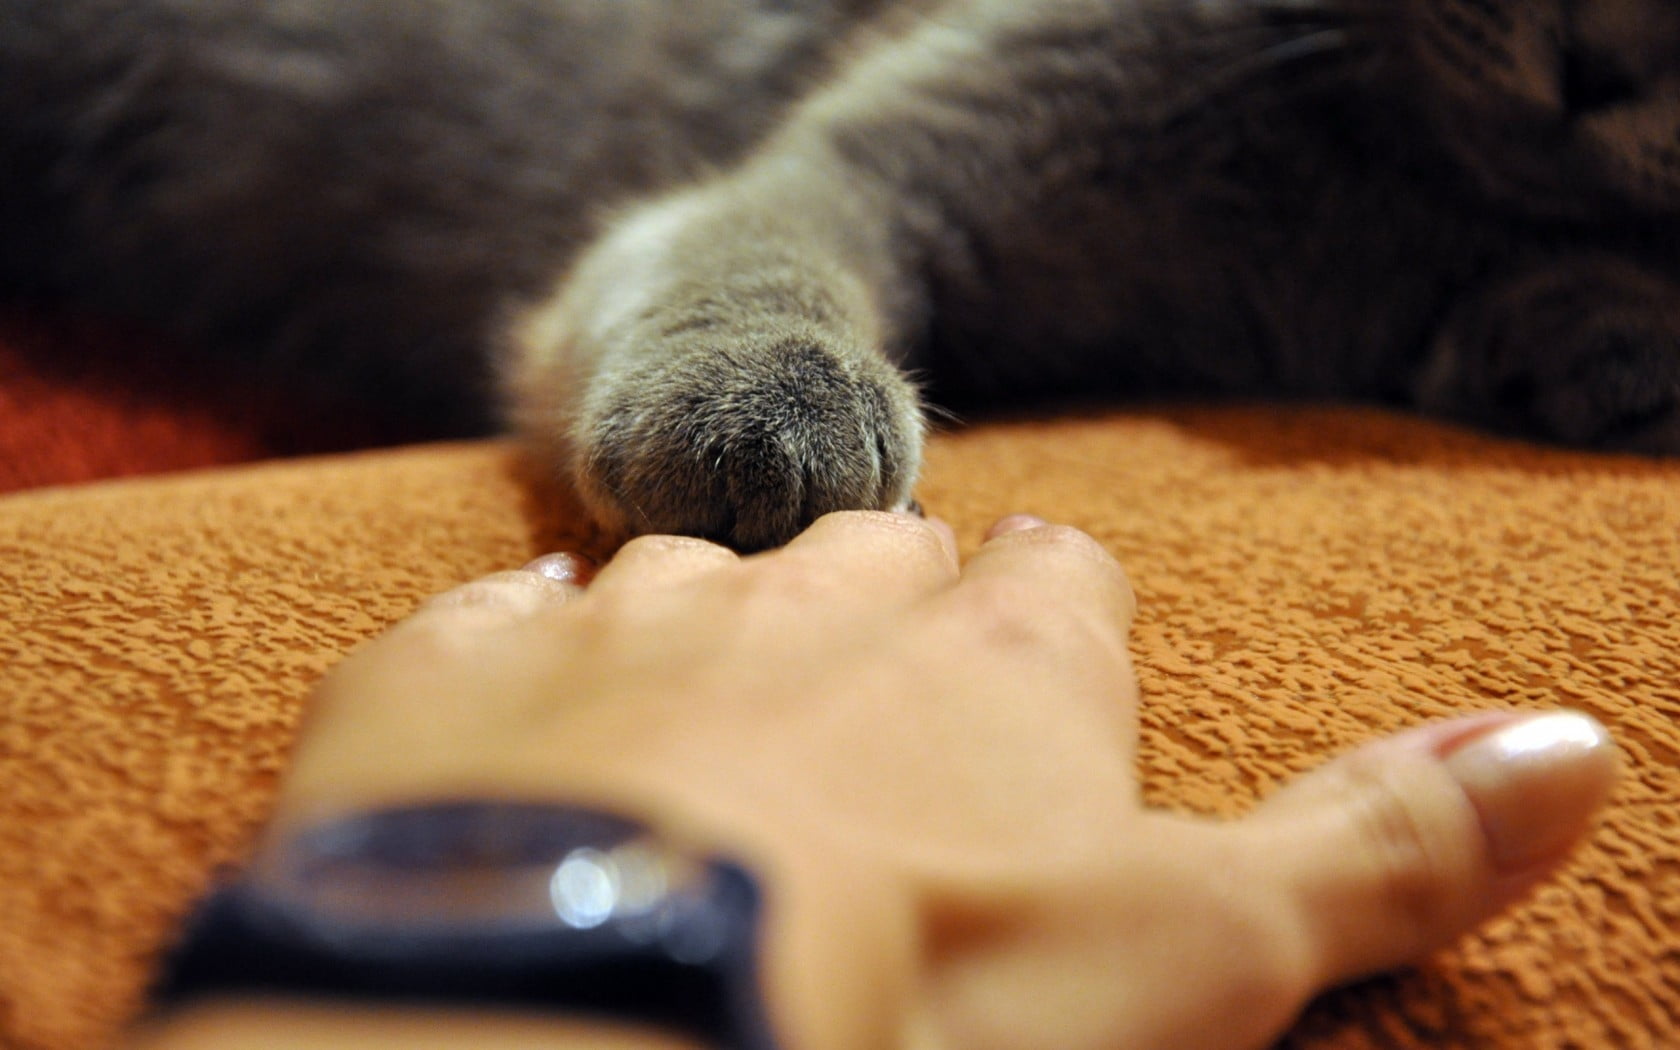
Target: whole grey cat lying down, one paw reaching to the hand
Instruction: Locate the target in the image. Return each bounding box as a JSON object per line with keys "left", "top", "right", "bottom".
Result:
{"left": 0, "top": 0, "right": 1680, "bottom": 548}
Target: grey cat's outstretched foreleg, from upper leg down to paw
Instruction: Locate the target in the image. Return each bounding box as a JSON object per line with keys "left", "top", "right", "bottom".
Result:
{"left": 507, "top": 0, "right": 1115, "bottom": 549}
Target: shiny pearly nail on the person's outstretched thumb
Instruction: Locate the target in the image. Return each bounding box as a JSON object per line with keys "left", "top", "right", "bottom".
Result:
{"left": 1443, "top": 711, "right": 1616, "bottom": 874}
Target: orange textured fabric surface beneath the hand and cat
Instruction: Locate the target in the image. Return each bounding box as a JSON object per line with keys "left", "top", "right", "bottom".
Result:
{"left": 0, "top": 408, "right": 1680, "bottom": 1050}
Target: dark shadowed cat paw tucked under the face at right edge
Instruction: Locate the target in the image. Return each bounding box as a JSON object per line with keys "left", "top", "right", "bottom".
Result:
{"left": 1420, "top": 265, "right": 1680, "bottom": 455}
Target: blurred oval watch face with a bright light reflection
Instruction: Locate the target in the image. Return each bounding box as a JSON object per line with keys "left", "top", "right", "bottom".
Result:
{"left": 250, "top": 803, "right": 709, "bottom": 937}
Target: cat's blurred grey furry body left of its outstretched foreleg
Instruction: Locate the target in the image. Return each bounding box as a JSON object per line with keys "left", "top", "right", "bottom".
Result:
{"left": 0, "top": 0, "right": 850, "bottom": 433}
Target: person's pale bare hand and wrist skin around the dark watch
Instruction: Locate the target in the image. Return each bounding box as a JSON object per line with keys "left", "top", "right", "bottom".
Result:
{"left": 134, "top": 512, "right": 1616, "bottom": 1050}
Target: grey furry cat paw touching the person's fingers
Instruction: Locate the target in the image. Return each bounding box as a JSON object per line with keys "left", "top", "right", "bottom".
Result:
{"left": 573, "top": 334, "right": 922, "bottom": 551}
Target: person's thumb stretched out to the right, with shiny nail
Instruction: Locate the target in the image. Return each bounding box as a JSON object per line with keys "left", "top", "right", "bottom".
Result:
{"left": 1236, "top": 711, "right": 1618, "bottom": 988}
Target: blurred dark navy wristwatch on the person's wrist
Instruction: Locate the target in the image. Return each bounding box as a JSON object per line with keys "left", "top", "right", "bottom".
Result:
{"left": 153, "top": 801, "right": 776, "bottom": 1050}
